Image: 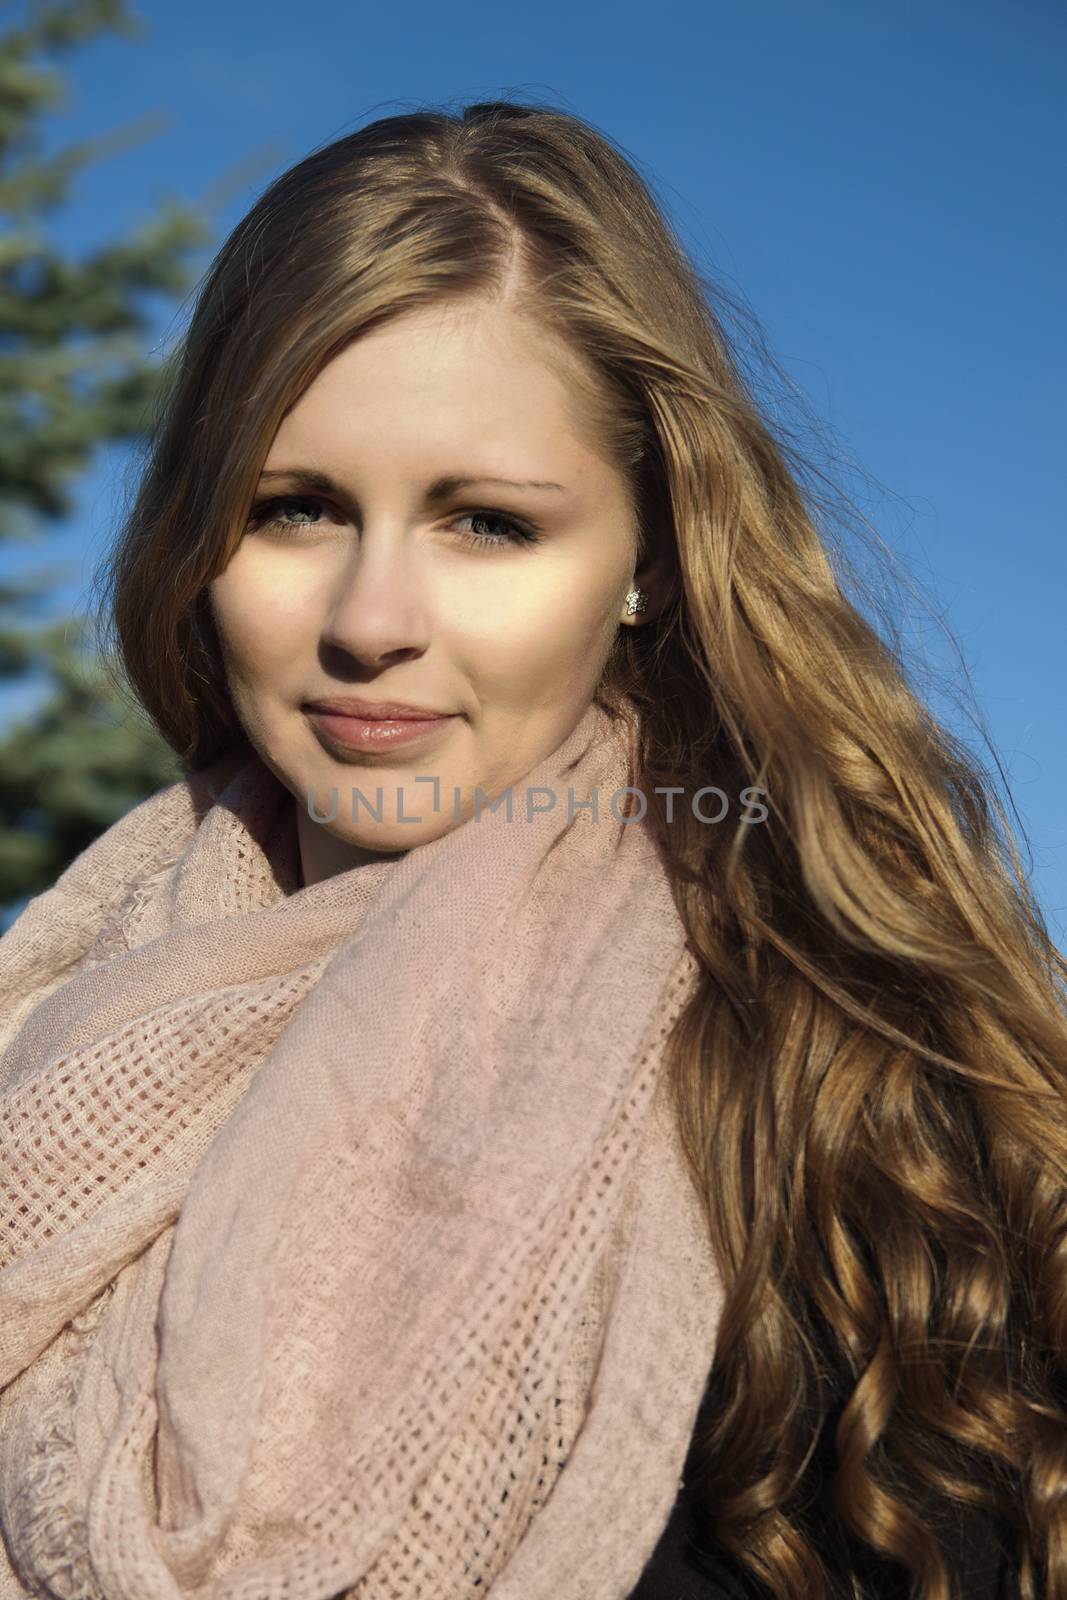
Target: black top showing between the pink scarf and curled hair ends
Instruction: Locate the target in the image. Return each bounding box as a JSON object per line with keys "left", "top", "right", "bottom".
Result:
{"left": 629, "top": 1388, "right": 1023, "bottom": 1600}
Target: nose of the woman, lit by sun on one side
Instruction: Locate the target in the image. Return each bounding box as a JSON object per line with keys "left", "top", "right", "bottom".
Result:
{"left": 322, "top": 526, "right": 430, "bottom": 669}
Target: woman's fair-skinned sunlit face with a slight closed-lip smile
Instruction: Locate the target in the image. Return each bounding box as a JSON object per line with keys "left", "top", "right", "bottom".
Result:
{"left": 210, "top": 306, "right": 653, "bottom": 883}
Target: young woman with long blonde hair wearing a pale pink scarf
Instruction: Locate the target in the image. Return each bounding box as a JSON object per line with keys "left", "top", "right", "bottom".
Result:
{"left": 0, "top": 102, "right": 1067, "bottom": 1600}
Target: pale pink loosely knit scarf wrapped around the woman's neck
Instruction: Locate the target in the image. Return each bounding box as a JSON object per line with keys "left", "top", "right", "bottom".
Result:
{"left": 0, "top": 704, "right": 720, "bottom": 1600}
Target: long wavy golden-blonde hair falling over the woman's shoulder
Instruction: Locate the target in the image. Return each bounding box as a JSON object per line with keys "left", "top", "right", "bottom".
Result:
{"left": 93, "top": 101, "right": 1067, "bottom": 1600}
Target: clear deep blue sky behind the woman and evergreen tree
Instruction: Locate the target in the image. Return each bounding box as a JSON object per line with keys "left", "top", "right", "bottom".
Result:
{"left": 0, "top": 0, "right": 1067, "bottom": 944}
